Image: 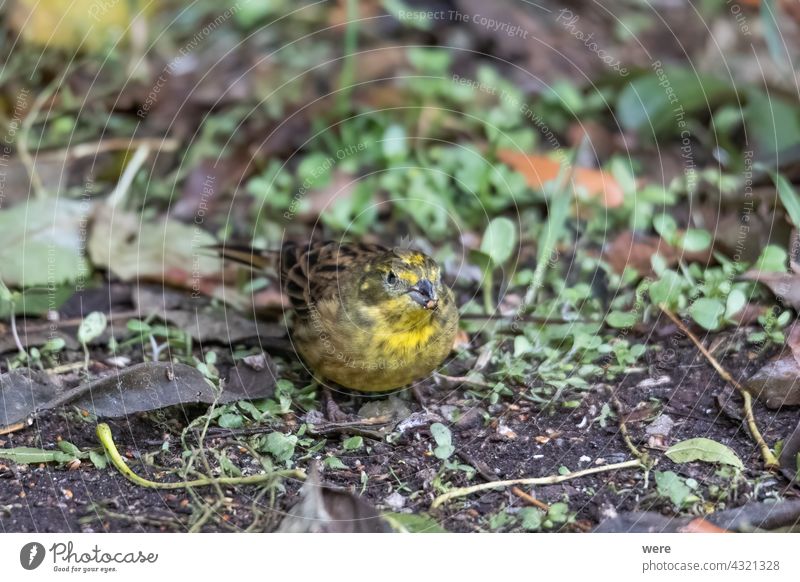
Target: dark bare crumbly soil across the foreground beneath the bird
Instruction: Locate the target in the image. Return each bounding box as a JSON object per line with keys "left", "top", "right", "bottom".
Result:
{"left": 0, "top": 322, "right": 797, "bottom": 532}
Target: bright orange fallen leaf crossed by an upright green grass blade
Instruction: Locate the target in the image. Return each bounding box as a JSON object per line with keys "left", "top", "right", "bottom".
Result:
{"left": 497, "top": 150, "right": 624, "bottom": 208}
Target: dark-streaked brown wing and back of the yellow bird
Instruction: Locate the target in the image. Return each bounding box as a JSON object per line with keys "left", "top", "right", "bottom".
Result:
{"left": 280, "top": 241, "right": 388, "bottom": 316}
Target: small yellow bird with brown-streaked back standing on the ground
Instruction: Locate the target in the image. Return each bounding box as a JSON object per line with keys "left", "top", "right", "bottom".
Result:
{"left": 216, "top": 240, "right": 459, "bottom": 419}
